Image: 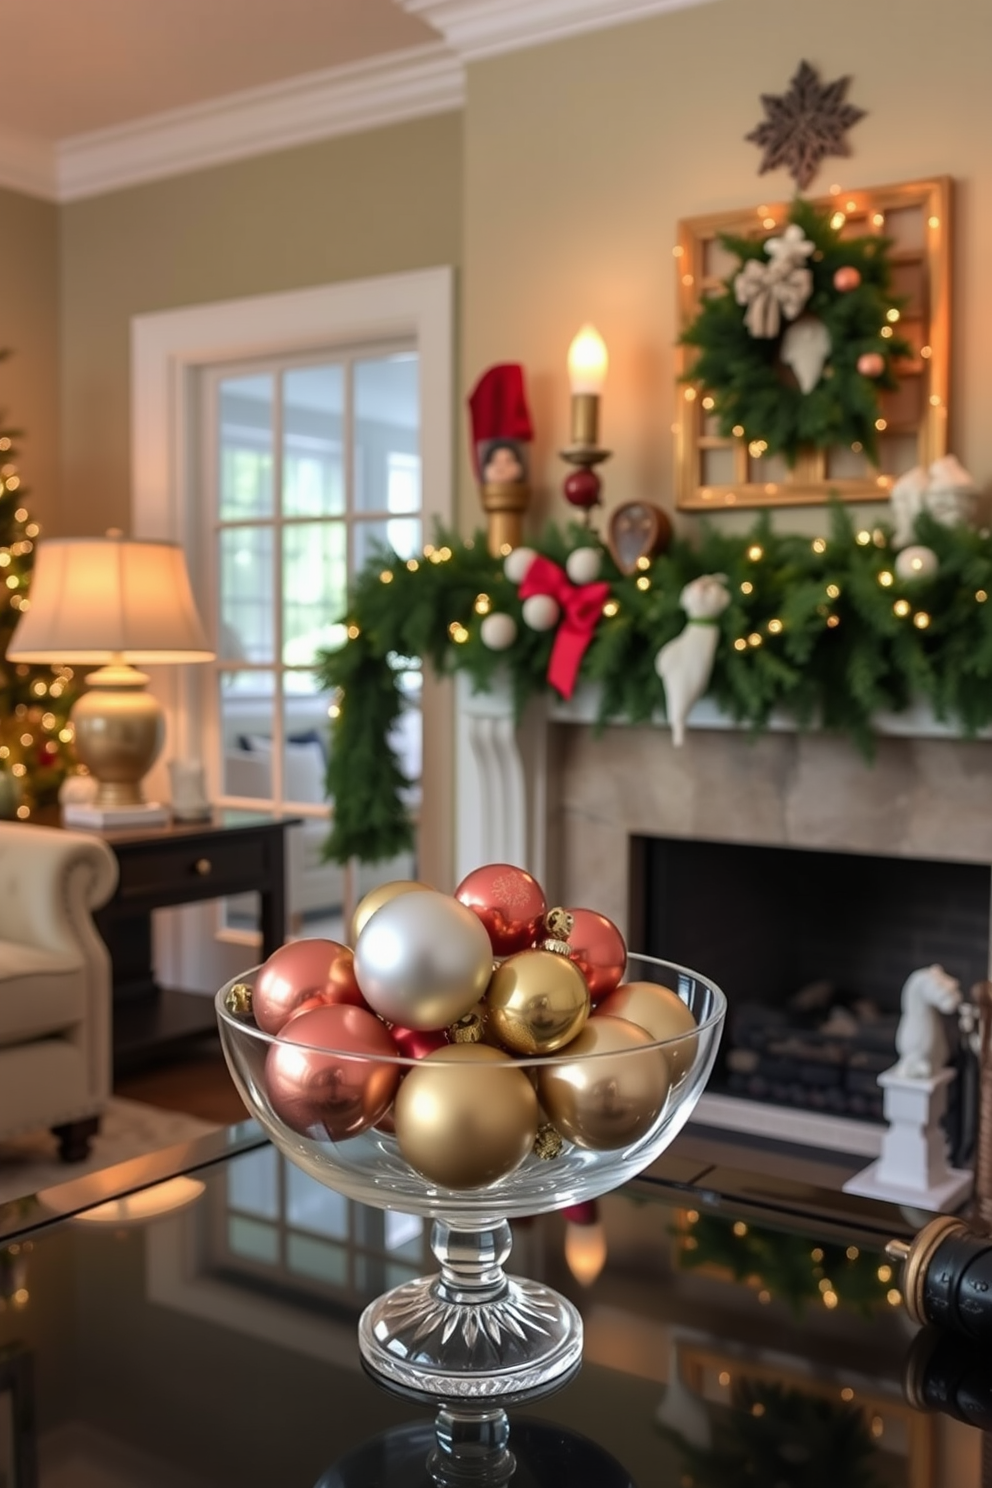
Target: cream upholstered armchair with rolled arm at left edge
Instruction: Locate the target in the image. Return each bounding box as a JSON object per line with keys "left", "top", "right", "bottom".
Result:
{"left": 0, "top": 821, "right": 117, "bottom": 1162}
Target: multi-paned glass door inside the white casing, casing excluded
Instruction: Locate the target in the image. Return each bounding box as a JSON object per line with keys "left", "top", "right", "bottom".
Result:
{"left": 202, "top": 342, "right": 424, "bottom": 937}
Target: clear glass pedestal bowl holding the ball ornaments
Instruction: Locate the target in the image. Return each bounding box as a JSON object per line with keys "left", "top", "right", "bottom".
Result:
{"left": 216, "top": 955, "right": 726, "bottom": 1406}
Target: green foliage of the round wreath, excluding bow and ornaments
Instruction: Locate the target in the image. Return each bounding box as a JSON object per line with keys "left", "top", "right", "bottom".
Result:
{"left": 681, "top": 199, "right": 913, "bottom": 466}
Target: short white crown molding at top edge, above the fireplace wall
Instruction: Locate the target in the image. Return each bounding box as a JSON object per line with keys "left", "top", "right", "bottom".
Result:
{"left": 399, "top": 0, "right": 722, "bottom": 62}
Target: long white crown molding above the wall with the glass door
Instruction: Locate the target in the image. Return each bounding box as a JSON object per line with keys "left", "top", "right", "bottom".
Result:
{"left": 56, "top": 43, "right": 466, "bottom": 201}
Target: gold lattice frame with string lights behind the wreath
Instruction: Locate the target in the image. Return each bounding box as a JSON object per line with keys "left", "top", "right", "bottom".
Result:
{"left": 674, "top": 176, "right": 952, "bottom": 512}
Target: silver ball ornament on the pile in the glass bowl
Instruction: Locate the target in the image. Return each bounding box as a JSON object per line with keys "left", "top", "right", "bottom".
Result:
{"left": 355, "top": 888, "right": 492, "bottom": 1028}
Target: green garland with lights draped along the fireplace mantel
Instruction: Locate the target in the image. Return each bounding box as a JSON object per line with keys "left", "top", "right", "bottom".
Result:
{"left": 317, "top": 504, "right": 992, "bottom": 862}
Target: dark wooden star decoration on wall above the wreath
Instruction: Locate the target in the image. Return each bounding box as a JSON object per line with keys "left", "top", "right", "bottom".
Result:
{"left": 745, "top": 62, "right": 864, "bottom": 190}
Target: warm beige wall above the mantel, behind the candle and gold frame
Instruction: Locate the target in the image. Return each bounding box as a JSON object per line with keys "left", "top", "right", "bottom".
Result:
{"left": 463, "top": 0, "right": 992, "bottom": 525}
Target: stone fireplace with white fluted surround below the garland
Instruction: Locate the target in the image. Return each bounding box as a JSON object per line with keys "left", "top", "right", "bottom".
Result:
{"left": 457, "top": 680, "right": 992, "bottom": 1158}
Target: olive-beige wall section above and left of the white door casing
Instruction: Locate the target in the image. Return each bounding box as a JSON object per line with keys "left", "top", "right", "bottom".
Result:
{"left": 58, "top": 113, "right": 461, "bottom": 534}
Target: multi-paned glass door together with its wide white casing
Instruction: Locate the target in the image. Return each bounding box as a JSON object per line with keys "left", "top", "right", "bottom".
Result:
{"left": 131, "top": 268, "right": 454, "bottom": 991}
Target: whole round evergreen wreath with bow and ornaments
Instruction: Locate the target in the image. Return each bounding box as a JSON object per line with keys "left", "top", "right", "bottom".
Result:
{"left": 681, "top": 199, "right": 913, "bottom": 466}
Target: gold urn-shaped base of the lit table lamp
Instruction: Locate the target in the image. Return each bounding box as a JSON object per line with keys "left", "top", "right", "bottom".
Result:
{"left": 71, "top": 665, "right": 165, "bottom": 812}
